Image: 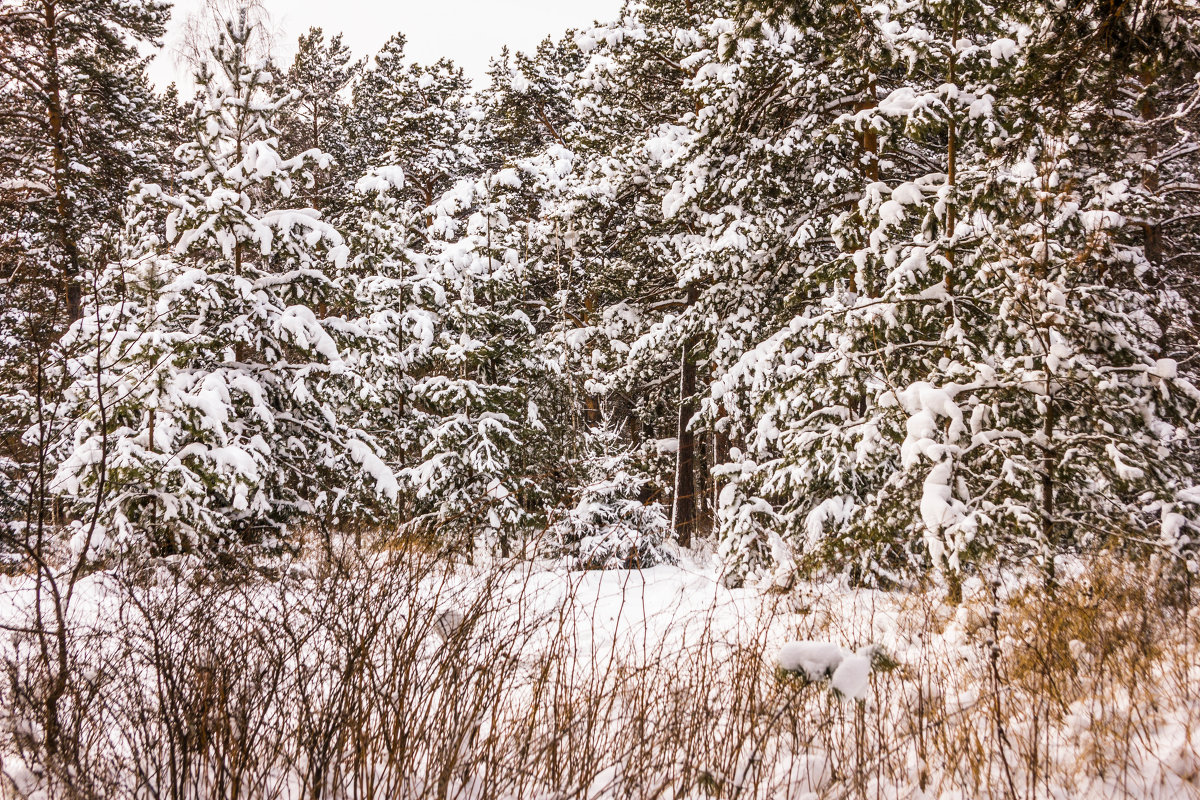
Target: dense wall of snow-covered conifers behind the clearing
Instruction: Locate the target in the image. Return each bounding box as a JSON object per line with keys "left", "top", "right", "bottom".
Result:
{"left": 0, "top": 0, "right": 1200, "bottom": 575}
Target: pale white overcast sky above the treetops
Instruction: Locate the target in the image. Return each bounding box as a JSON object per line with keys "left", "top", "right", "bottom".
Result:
{"left": 150, "top": 0, "right": 620, "bottom": 88}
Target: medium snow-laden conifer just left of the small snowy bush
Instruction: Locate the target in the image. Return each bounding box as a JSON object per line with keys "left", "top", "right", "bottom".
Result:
{"left": 401, "top": 170, "right": 571, "bottom": 555}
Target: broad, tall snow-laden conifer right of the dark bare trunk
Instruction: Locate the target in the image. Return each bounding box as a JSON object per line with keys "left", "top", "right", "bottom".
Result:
{"left": 700, "top": 2, "right": 1194, "bottom": 587}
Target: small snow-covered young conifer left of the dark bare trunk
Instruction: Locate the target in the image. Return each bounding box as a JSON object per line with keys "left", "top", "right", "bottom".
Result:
{"left": 550, "top": 471, "right": 677, "bottom": 570}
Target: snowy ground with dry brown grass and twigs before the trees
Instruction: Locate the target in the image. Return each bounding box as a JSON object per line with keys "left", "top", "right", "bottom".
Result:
{"left": 0, "top": 548, "right": 1200, "bottom": 800}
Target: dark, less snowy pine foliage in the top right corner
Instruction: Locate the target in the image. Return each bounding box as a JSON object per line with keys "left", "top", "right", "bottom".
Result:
{"left": 1021, "top": 1, "right": 1200, "bottom": 356}
